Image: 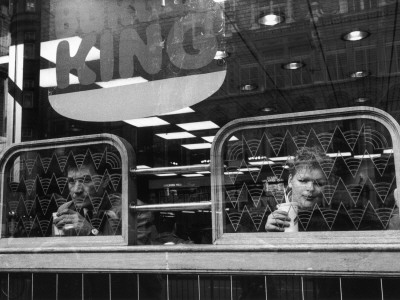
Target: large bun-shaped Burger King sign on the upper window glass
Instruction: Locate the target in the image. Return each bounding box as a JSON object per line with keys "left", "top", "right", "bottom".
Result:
{"left": 45, "top": 0, "right": 226, "bottom": 121}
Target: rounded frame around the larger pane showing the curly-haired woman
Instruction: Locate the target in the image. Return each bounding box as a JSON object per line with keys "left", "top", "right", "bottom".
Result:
{"left": 210, "top": 106, "right": 400, "bottom": 250}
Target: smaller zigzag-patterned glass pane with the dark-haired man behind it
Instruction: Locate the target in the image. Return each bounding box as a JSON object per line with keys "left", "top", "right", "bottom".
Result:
{"left": 2, "top": 144, "right": 122, "bottom": 238}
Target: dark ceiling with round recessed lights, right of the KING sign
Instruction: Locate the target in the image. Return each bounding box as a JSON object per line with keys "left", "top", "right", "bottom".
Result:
{"left": 193, "top": 0, "right": 400, "bottom": 125}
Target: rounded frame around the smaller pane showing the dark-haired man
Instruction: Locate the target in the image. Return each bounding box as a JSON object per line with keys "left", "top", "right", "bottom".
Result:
{"left": 0, "top": 134, "right": 136, "bottom": 248}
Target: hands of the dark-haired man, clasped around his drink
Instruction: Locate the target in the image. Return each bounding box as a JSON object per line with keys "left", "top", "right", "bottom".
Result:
{"left": 53, "top": 209, "right": 92, "bottom": 235}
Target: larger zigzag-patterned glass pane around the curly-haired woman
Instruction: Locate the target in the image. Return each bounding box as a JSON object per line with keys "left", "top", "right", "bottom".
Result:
{"left": 224, "top": 120, "right": 399, "bottom": 232}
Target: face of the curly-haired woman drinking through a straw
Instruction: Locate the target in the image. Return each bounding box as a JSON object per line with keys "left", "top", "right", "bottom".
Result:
{"left": 288, "top": 165, "right": 327, "bottom": 209}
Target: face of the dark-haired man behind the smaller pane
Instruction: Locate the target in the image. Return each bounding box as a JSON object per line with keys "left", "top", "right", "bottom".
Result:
{"left": 68, "top": 166, "right": 97, "bottom": 206}
